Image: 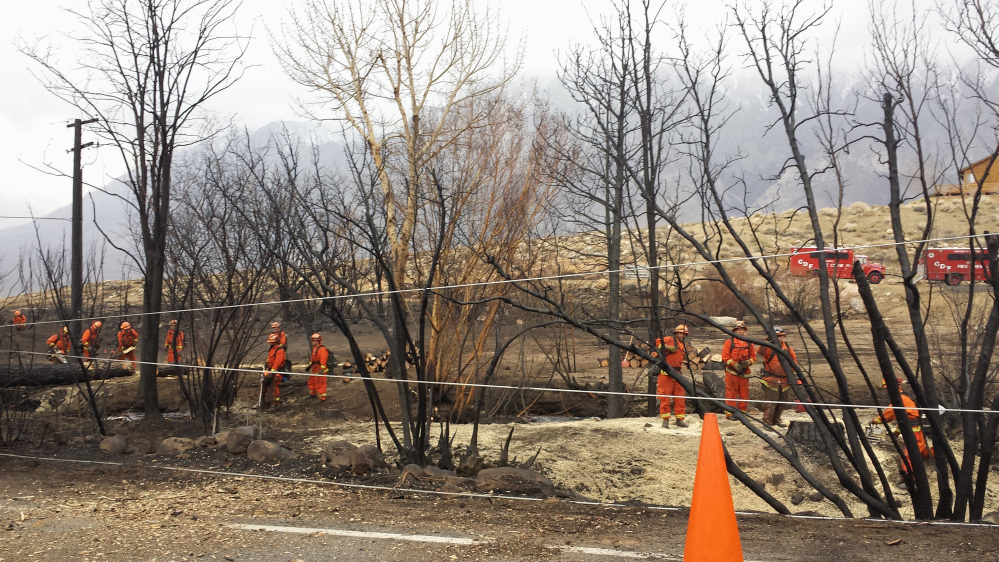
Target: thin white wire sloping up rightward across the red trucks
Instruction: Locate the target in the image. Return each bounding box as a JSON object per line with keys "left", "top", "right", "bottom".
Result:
{"left": 1, "top": 234, "right": 983, "bottom": 326}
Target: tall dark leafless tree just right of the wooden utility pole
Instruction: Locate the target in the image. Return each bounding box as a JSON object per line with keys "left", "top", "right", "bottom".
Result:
{"left": 21, "top": 0, "right": 245, "bottom": 418}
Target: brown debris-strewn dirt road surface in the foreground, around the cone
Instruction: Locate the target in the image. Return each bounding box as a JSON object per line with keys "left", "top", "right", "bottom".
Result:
{"left": 0, "top": 448, "right": 999, "bottom": 562}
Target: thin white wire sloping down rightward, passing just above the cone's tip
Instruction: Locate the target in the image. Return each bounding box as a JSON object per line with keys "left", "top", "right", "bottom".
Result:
{"left": 0, "top": 349, "right": 999, "bottom": 414}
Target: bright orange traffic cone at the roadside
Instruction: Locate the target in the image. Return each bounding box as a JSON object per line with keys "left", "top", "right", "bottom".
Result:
{"left": 683, "top": 414, "right": 742, "bottom": 562}
